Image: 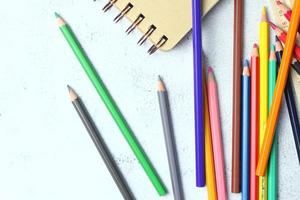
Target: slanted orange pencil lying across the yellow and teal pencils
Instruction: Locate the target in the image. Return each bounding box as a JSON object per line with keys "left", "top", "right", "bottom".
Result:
{"left": 256, "top": 1, "right": 300, "bottom": 176}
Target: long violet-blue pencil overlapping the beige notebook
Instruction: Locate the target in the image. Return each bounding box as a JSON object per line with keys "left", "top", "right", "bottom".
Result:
{"left": 192, "top": 0, "right": 205, "bottom": 187}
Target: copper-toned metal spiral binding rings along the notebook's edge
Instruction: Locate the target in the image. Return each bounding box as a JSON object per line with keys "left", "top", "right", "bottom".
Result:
{"left": 100, "top": 0, "right": 168, "bottom": 55}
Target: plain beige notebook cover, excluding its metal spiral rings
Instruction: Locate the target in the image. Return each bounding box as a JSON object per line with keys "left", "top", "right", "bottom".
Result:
{"left": 114, "top": 0, "right": 219, "bottom": 51}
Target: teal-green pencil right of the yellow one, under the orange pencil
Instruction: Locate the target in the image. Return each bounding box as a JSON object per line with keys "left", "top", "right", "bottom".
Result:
{"left": 268, "top": 45, "right": 278, "bottom": 200}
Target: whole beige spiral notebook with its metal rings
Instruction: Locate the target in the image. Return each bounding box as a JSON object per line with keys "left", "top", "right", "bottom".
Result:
{"left": 103, "top": 0, "right": 219, "bottom": 54}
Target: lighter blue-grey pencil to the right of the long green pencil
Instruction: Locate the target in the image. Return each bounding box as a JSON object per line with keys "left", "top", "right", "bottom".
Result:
{"left": 157, "top": 77, "right": 183, "bottom": 200}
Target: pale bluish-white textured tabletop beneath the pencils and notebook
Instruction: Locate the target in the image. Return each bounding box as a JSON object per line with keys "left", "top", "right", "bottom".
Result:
{"left": 0, "top": 0, "right": 300, "bottom": 200}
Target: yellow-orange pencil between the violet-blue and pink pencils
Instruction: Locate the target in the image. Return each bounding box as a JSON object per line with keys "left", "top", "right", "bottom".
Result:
{"left": 203, "top": 69, "right": 217, "bottom": 200}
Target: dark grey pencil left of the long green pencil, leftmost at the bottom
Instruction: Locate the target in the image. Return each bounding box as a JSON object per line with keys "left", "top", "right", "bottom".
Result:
{"left": 68, "top": 86, "right": 134, "bottom": 200}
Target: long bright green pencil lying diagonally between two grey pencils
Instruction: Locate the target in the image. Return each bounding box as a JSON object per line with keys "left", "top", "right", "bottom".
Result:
{"left": 55, "top": 13, "right": 167, "bottom": 196}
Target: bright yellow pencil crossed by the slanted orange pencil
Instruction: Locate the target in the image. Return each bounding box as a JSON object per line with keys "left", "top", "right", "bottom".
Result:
{"left": 259, "top": 7, "right": 269, "bottom": 200}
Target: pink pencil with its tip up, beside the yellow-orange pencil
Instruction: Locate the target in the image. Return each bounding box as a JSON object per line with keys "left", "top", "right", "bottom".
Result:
{"left": 207, "top": 67, "right": 227, "bottom": 200}
